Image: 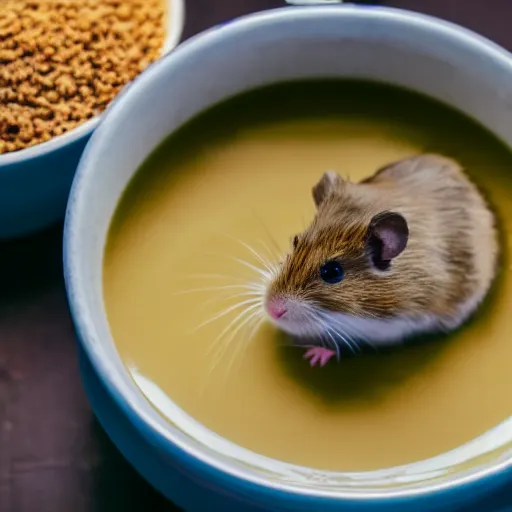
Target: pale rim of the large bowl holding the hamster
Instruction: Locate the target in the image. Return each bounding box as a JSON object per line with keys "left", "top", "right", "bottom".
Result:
{"left": 64, "top": 5, "right": 512, "bottom": 503}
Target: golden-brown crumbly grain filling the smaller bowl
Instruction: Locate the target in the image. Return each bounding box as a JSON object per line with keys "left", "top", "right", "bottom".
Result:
{"left": 0, "top": 0, "right": 165, "bottom": 153}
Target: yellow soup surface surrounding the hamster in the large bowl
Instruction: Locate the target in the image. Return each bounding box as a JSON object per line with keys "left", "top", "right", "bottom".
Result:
{"left": 104, "top": 81, "right": 512, "bottom": 471}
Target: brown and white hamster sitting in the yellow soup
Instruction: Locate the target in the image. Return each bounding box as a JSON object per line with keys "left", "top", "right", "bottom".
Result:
{"left": 265, "top": 154, "right": 498, "bottom": 366}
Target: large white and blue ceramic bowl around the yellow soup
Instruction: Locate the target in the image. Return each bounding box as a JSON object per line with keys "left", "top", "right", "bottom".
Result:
{"left": 64, "top": 6, "right": 512, "bottom": 512}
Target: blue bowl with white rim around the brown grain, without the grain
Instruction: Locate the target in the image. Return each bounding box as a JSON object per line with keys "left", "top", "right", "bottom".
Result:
{"left": 0, "top": 0, "right": 185, "bottom": 239}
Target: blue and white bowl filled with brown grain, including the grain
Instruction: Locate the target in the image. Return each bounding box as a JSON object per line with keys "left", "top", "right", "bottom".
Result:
{"left": 0, "top": 0, "right": 184, "bottom": 239}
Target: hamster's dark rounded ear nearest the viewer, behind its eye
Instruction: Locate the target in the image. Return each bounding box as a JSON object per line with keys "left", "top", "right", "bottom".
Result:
{"left": 368, "top": 212, "right": 409, "bottom": 270}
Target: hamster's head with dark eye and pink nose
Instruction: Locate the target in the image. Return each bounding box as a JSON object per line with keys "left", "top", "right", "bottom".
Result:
{"left": 265, "top": 172, "right": 409, "bottom": 338}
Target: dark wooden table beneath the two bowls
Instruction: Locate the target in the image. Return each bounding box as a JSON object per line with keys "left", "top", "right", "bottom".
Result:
{"left": 0, "top": 0, "right": 512, "bottom": 512}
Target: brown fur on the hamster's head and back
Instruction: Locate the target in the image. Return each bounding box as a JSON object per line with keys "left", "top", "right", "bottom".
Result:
{"left": 268, "top": 155, "right": 498, "bottom": 327}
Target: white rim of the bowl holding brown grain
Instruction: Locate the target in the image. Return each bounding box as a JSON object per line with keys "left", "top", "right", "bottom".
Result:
{"left": 0, "top": 0, "right": 185, "bottom": 166}
